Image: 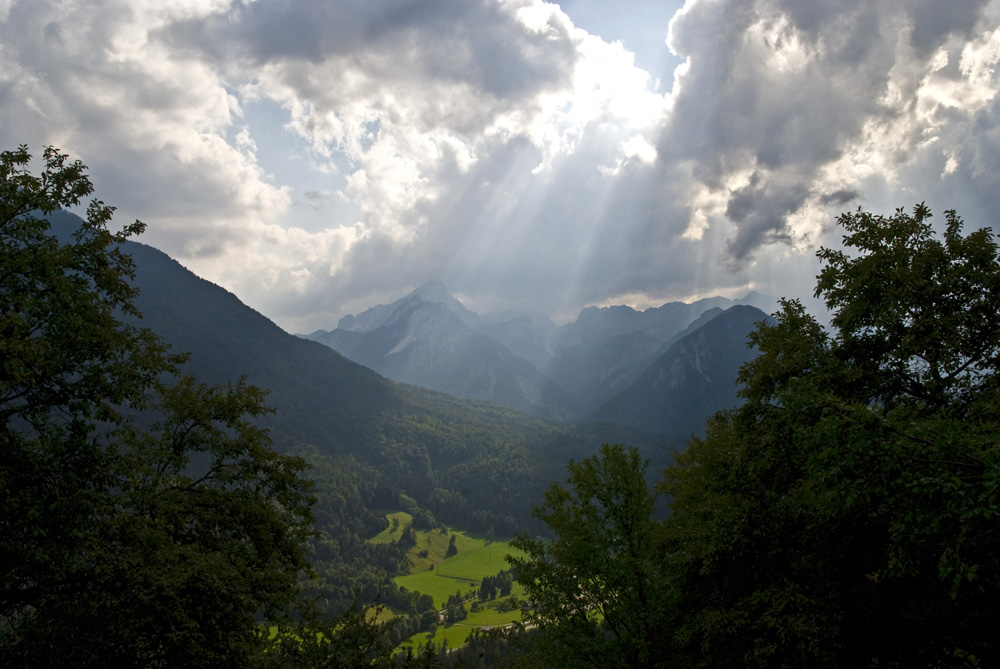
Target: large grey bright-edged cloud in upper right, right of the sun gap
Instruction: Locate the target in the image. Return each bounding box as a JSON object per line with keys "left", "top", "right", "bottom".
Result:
{"left": 658, "top": 0, "right": 997, "bottom": 266}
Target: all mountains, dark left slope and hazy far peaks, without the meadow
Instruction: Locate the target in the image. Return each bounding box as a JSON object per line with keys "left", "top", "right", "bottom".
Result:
{"left": 52, "top": 213, "right": 763, "bottom": 533}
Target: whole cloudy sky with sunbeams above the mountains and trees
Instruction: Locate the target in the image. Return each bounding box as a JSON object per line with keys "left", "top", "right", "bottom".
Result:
{"left": 0, "top": 0, "right": 1000, "bottom": 333}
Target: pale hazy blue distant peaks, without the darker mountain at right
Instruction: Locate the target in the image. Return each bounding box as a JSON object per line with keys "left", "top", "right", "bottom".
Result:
{"left": 304, "top": 281, "right": 777, "bottom": 432}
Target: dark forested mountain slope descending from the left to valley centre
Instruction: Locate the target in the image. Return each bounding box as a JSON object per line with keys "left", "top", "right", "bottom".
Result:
{"left": 49, "top": 212, "right": 656, "bottom": 534}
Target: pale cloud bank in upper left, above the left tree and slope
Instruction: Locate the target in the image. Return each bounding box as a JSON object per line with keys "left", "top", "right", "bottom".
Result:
{"left": 0, "top": 0, "right": 288, "bottom": 257}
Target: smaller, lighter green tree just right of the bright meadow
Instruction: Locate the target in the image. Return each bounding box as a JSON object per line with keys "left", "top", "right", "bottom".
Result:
{"left": 507, "top": 444, "right": 665, "bottom": 667}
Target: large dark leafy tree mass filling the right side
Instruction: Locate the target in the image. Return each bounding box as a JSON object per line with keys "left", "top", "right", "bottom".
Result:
{"left": 660, "top": 205, "right": 1000, "bottom": 667}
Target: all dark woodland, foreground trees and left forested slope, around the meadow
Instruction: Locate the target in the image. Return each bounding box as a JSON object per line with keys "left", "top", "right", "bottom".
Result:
{"left": 0, "top": 147, "right": 1000, "bottom": 667}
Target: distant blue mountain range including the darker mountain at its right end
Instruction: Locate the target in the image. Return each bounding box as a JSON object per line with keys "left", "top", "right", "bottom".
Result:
{"left": 300, "top": 281, "right": 776, "bottom": 434}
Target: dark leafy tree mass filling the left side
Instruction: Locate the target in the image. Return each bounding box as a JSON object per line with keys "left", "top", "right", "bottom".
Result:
{"left": 0, "top": 146, "right": 311, "bottom": 666}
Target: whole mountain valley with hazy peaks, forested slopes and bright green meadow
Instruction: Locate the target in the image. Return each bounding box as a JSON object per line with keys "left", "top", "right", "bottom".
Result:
{"left": 19, "top": 212, "right": 766, "bottom": 660}
